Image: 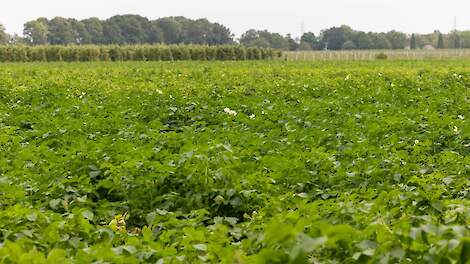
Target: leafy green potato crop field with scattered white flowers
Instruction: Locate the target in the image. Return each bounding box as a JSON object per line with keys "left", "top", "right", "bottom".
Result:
{"left": 0, "top": 60, "right": 470, "bottom": 264}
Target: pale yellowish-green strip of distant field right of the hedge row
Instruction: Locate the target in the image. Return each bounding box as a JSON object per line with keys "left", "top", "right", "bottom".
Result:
{"left": 283, "top": 49, "right": 470, "bottom": 61}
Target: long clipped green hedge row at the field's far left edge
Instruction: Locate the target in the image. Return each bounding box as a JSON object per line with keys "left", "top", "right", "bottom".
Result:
{"left": 0, "top": 45, "right": 282, "bottom": 62}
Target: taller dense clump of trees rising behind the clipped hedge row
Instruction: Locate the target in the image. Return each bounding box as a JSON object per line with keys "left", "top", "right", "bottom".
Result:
{"left": 2, "top": 15, "right": 233, "bottom": 45}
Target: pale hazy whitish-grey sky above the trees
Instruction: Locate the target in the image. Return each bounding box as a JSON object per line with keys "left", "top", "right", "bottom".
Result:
{"left": 0, "top": 0, "right": 470, "bottom": 36}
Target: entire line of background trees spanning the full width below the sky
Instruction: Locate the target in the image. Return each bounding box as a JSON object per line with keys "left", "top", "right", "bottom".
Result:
{"left": 0, "top": 15, "right": 470, "bottom": 50}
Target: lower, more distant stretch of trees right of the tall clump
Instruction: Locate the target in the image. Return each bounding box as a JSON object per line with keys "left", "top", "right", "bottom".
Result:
{"left": 240, "top": 25, "right": 470, "bottom": 51}
